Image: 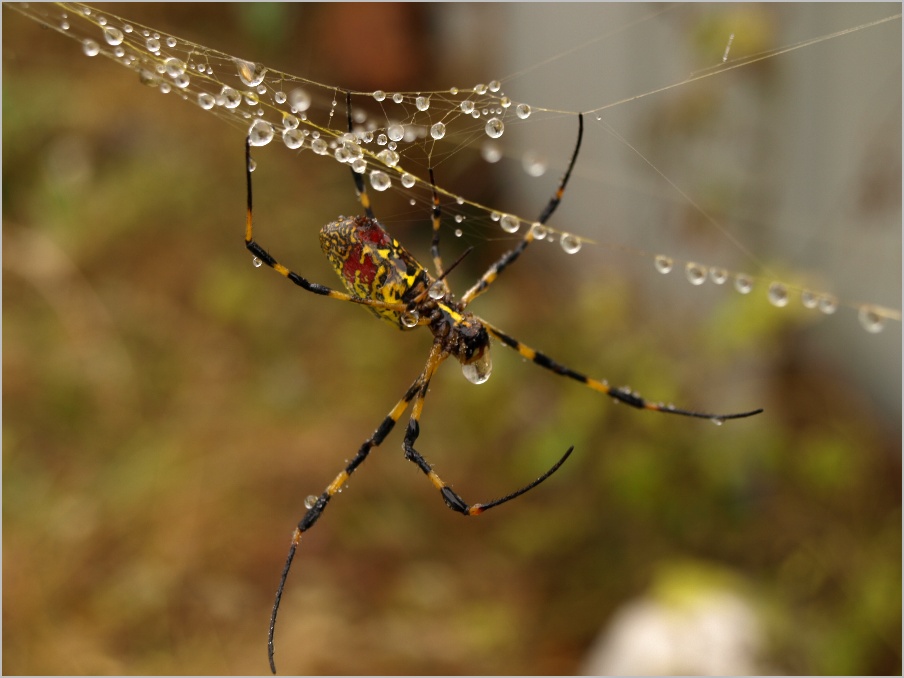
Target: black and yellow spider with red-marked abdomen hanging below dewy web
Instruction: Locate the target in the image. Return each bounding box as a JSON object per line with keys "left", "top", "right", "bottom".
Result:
{"left": 245, "top": 93, "right": 762, "bottom": 673}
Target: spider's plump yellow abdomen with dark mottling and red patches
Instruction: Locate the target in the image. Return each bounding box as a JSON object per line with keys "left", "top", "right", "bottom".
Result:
{"left": 320, "top": 216, "right": 430, "bottom": 328}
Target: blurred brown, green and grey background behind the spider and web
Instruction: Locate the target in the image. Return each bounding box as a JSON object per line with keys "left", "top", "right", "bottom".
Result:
{"left": 2, "top": 3, "right": 901, "bottom": 674}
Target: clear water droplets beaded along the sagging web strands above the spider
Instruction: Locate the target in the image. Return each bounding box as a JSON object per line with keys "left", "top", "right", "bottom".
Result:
{"left": 10, "top": 3, "right": 901, "bottom": 333}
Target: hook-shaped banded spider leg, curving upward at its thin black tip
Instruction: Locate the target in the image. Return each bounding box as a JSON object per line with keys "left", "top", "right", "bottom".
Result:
{"left": 402, "top": 343, "right": 574, "bottom": 516}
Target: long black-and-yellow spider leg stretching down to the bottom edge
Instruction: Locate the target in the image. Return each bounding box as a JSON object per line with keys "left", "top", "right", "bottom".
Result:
{"left": 267, "top": 373, "right": 425, "bottom": 673}
